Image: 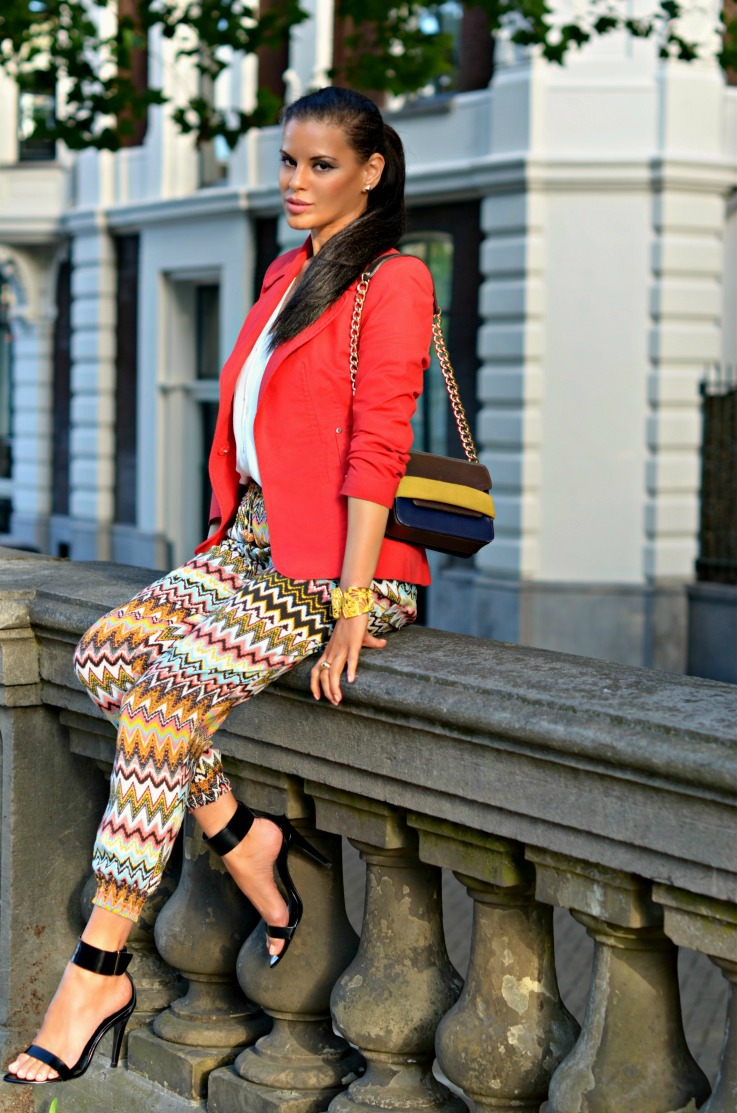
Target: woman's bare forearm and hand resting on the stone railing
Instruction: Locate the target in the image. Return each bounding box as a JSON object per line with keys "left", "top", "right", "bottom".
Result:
{"left": 309, "top": 499, "right": 389, "bottom": 707}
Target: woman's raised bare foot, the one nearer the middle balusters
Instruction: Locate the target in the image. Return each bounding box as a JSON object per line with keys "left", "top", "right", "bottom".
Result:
{"left": 223, "top": 816, "right": 289, "bottom": 955}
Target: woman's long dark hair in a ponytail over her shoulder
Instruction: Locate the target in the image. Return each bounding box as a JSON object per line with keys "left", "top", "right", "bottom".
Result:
{"left": 272, "top": 86, "right": 405, "bottom": 347}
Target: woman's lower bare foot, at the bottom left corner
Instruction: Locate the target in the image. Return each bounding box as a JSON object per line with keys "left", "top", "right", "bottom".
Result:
{"left": 8, "top": 963, "right": 130, "bottom": 1082}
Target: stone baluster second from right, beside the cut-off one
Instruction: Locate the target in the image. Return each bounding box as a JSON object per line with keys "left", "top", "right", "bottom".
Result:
{"left": 527, "top": 848, "right": 709, "bottom": 1113}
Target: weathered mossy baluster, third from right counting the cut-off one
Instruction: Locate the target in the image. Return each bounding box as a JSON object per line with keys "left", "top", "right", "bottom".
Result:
{"left": 409, "top": 815, "right": 579, "bottom": 1113}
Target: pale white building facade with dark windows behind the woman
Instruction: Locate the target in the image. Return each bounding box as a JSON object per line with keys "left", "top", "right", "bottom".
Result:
{"left": 0, "top": 0, "right": 737, "bottom": 671}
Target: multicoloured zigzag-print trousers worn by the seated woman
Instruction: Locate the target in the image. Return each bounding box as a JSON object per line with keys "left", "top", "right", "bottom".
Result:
{"left": 75, "top": 483, "right": 416, "bottom": 920}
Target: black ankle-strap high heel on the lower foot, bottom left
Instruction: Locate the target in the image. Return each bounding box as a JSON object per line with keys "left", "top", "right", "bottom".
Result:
{"left": 2, "top": 939, "right": 136, "bottom": 1086}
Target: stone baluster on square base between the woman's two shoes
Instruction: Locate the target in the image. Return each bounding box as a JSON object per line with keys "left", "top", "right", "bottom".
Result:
{"left": 128, "top": 816, "right": 268, "bottom": 1100}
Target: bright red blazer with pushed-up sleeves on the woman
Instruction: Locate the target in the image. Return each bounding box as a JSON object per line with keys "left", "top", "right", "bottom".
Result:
{"left": 197, "top": 240, "right": 433, "bottom": 583}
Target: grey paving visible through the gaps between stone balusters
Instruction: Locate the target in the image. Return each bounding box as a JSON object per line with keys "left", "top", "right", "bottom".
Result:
{"left": 343, "top": 840, "right": 728, "bottom": 1086}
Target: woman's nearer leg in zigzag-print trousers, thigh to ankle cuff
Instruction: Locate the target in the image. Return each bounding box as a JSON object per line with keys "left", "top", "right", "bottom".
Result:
{"left": 87, "top": 569, "right": 332, "bottom": 918}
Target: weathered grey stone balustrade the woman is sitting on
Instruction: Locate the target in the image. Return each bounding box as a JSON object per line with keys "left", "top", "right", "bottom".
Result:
{"left": 0, "top": 551, "right": 737, "bottom": 1113}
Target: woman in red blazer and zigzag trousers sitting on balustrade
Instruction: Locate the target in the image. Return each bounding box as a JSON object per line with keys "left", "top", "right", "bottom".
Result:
{"left": 6, "top": 88, "right": 433, "bottom": 1084}
